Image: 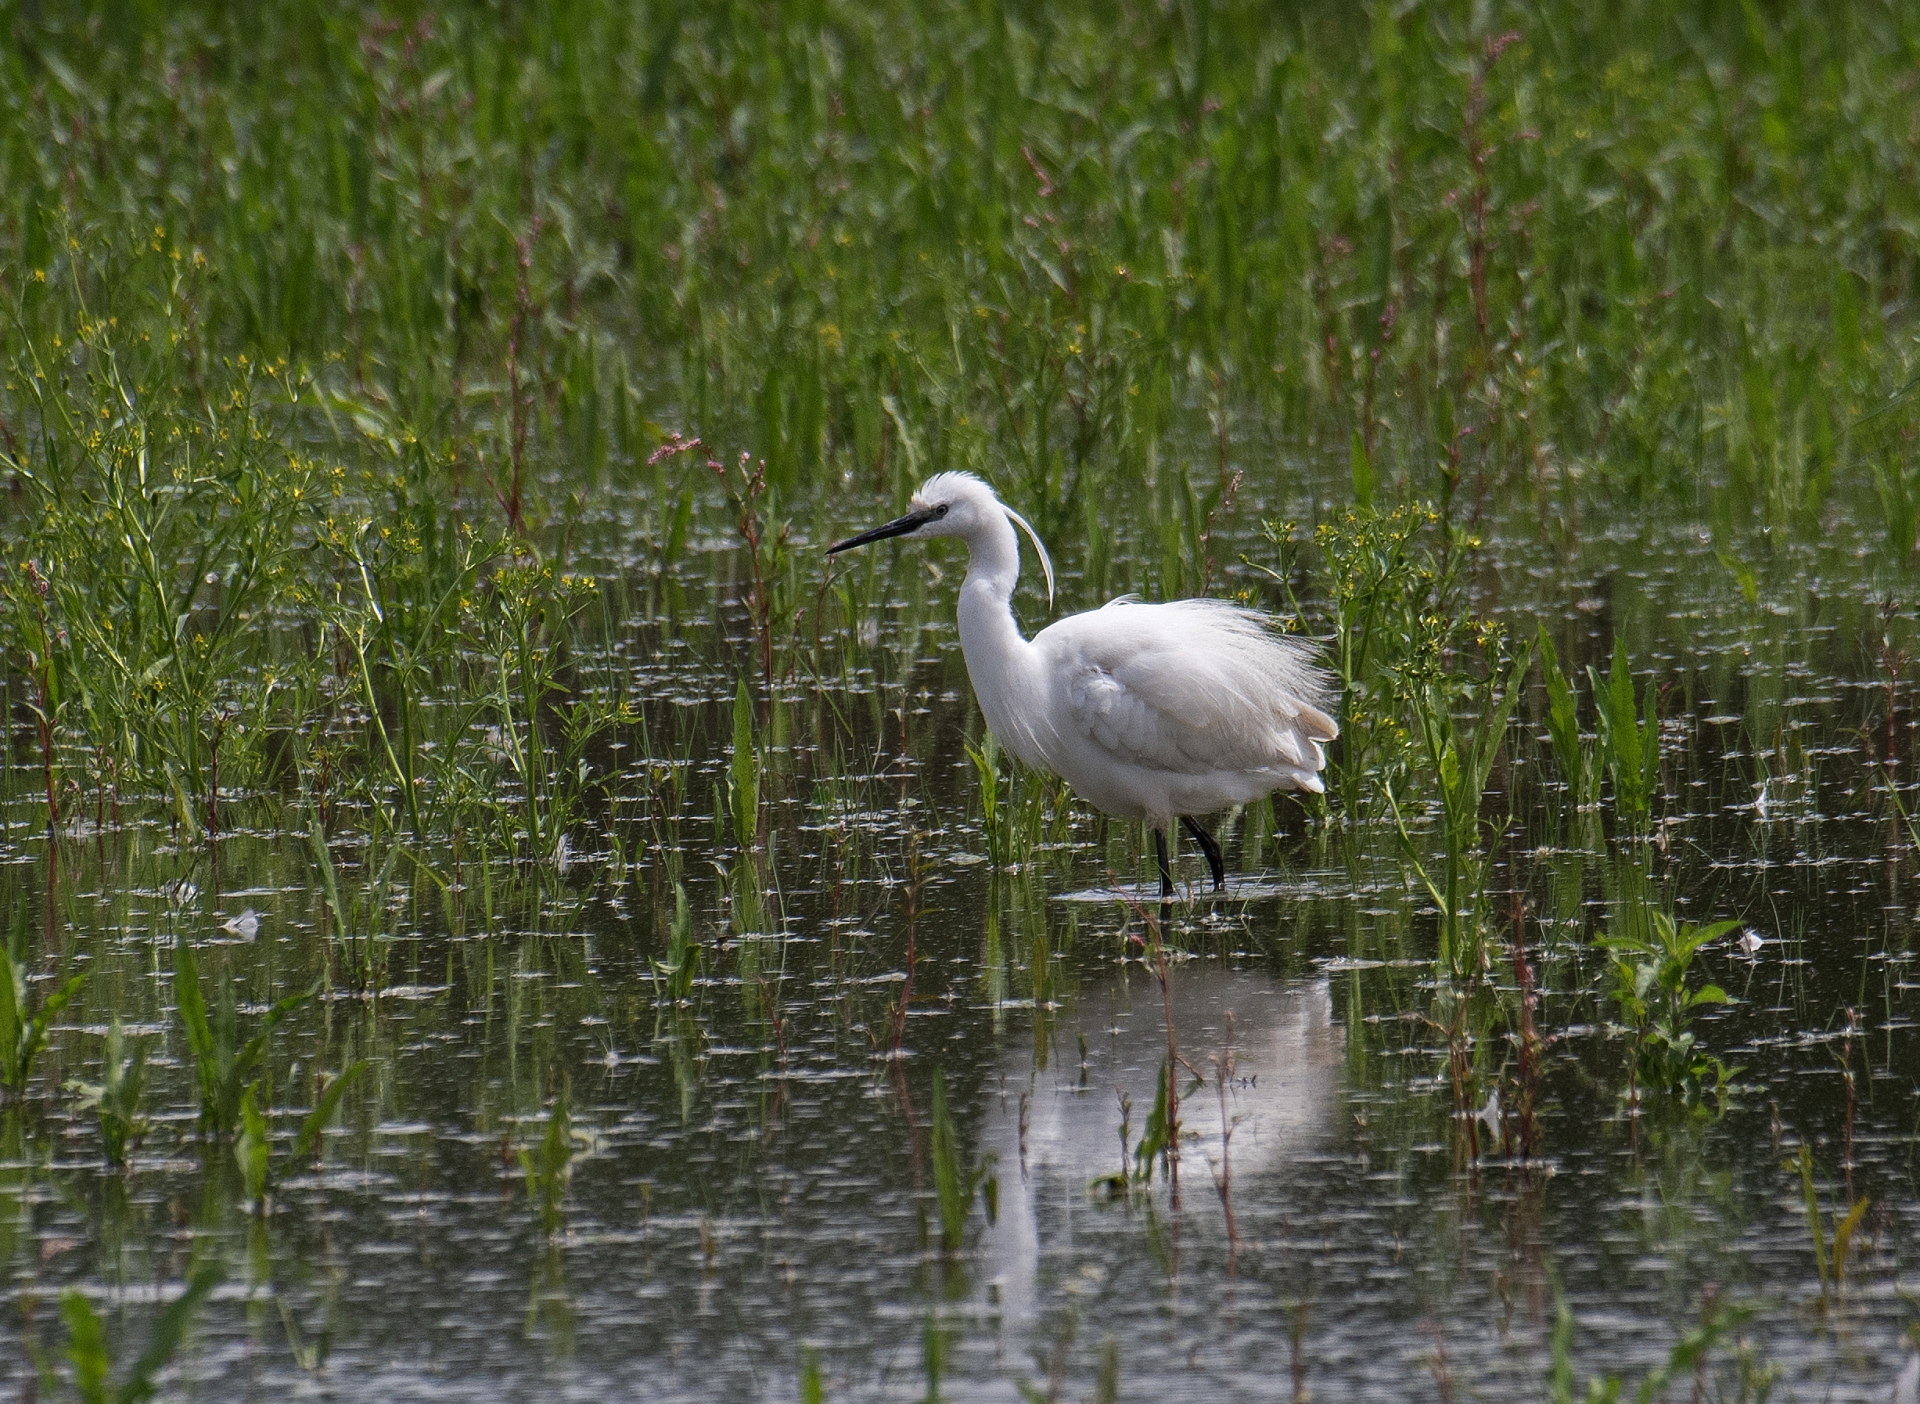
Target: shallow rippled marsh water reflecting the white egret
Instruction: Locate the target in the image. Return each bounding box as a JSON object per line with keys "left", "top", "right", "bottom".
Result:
{"left": 0, "top": 495, "right": 1920, "bottom": 1400}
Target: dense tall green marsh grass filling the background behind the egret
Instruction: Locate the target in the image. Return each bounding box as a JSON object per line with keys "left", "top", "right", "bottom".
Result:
{"left": 0, "top": 2, "right": 1920, "bottom": 829}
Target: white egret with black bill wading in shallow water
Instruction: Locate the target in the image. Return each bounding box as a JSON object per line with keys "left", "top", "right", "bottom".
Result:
{"left": 828, "top": 472, "right": 1340, "bottom": 899}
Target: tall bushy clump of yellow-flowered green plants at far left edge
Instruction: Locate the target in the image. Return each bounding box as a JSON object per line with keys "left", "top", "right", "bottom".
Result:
{"left": 0, "top": 326, "right": 317, "bottom": 822}
